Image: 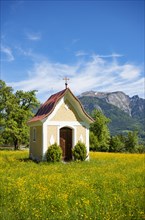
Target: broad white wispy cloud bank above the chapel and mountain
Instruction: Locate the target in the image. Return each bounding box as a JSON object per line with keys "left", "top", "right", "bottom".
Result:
{"left": 8, "top": 54, "right": 144, "bottom": 101}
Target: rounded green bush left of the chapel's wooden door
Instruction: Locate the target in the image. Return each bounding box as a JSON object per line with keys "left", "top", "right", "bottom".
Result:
{"left": 46, "top": 143, "right": 62, "bottom": 162}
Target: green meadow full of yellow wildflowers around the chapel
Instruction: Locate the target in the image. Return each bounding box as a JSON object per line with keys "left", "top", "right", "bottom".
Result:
{"left": 0, "top": 151, "right": 145, "bottom": 220}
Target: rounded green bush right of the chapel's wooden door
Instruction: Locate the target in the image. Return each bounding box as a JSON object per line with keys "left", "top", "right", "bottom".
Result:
{"left": 72, "top": 141, "right": 87, "bottom": 161}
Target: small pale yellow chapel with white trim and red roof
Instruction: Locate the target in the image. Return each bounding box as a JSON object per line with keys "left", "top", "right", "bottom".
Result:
{"left": 28, "top": 86, "right": 93, "bottom": 161}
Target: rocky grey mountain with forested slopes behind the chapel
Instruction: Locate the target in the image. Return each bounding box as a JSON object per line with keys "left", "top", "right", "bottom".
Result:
{"left": 78, "top": 91, "right": 145, "bottom": 141}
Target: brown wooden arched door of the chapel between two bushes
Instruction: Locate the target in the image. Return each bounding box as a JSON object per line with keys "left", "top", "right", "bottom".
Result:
{"left": 60, "top": 127, "right": 72, "bottom": 161}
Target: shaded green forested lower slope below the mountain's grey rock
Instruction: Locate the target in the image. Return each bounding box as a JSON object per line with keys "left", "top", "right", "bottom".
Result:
{"left": 79, "top": 96, "right": 144, "bottom": 138}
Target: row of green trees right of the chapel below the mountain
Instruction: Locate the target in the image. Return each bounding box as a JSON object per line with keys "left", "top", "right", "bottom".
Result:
{"left": 90, "top": 110, "right": 145, "bottom": 153}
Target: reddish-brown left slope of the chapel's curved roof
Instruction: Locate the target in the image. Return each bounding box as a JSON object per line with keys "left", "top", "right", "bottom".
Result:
{"left": 29, "top": 89, "right": 67, "bottom": 122}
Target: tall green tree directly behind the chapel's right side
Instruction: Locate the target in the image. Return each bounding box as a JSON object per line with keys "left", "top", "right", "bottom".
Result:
{"left": 90, "top": 110, "right": 110, "bottom": 151}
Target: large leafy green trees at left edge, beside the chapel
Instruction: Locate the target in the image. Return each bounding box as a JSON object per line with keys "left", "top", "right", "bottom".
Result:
{"left": 0, "top": 80, "right": 39, "bottom": 150}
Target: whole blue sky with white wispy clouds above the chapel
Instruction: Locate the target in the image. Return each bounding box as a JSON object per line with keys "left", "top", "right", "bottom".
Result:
{"left": 0, "top": 0, "right": 145, "bottom": 101}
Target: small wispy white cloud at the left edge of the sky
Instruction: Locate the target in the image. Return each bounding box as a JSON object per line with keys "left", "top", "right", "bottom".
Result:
{"left": 0, "top": 45, "right": 14, "bottom": 62}
